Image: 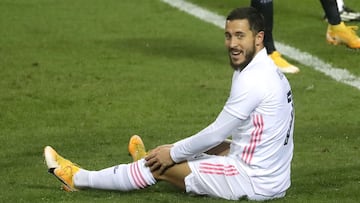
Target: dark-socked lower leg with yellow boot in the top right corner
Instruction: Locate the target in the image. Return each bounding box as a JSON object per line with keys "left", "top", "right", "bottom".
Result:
{"left": 320, "top": 0, "right": 360, "bottom": 49}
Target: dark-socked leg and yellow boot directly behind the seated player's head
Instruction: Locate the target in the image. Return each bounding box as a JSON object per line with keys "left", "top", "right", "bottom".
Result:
{"left": 250, "top": 0, "right": 300, "bottom": 73}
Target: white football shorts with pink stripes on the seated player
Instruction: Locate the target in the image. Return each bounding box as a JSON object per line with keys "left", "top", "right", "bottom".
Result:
{"left": 185, "top": 154, "right": 285, "bottom": 200}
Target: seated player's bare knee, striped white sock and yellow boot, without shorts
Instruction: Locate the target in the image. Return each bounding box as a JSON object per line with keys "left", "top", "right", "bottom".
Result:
{"left": 44, "top": 146, "right": 191, "bottom": 191}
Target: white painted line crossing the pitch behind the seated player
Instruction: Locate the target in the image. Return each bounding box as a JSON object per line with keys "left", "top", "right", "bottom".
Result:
{"left": 161, "top": 0, "right": 360, "bottom": 90}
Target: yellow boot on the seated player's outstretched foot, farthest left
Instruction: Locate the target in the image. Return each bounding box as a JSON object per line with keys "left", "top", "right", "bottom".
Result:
{"left": 44, "top": 146, "right": 80, "bottom": 192}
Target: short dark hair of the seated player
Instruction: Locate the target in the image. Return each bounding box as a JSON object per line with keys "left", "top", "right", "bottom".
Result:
{"left": 226, "top": 7, "right": 265, "bottom": 34}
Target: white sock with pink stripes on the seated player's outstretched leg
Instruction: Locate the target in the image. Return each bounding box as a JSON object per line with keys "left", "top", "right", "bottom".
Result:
{"left": 74, "top": 159, "right": 156, "bottom": 191}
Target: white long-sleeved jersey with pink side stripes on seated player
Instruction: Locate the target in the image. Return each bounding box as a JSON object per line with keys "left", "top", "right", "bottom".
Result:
{"left": 170, "top": 49, "right": 294, "bottom": 196}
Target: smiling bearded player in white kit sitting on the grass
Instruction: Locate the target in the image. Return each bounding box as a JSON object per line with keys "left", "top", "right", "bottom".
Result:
{"left": 44, "top": 7, "right": 295, "bottom": 200}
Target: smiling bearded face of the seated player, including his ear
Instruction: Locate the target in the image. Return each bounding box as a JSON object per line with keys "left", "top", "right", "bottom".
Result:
{"left": 225, "top": 19, "right": 264, "bottom": 70}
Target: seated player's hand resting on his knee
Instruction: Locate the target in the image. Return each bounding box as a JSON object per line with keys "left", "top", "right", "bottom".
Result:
{"left": 145, "top": 145, "right": 175, "bottom": 174}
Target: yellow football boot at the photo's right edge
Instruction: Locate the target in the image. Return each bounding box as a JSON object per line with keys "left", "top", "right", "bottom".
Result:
{"left": 326, "top": 22, "right": 360, "bottom": 49}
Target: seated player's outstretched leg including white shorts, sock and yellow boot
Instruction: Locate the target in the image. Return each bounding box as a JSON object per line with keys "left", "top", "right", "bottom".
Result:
{"left": 44, "top": 146, "right": 285, "bottom": 200}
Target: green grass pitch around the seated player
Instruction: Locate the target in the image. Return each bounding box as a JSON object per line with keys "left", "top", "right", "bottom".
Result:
{"left": 0, "top": 0, "right": 360, "bottom": 203}
